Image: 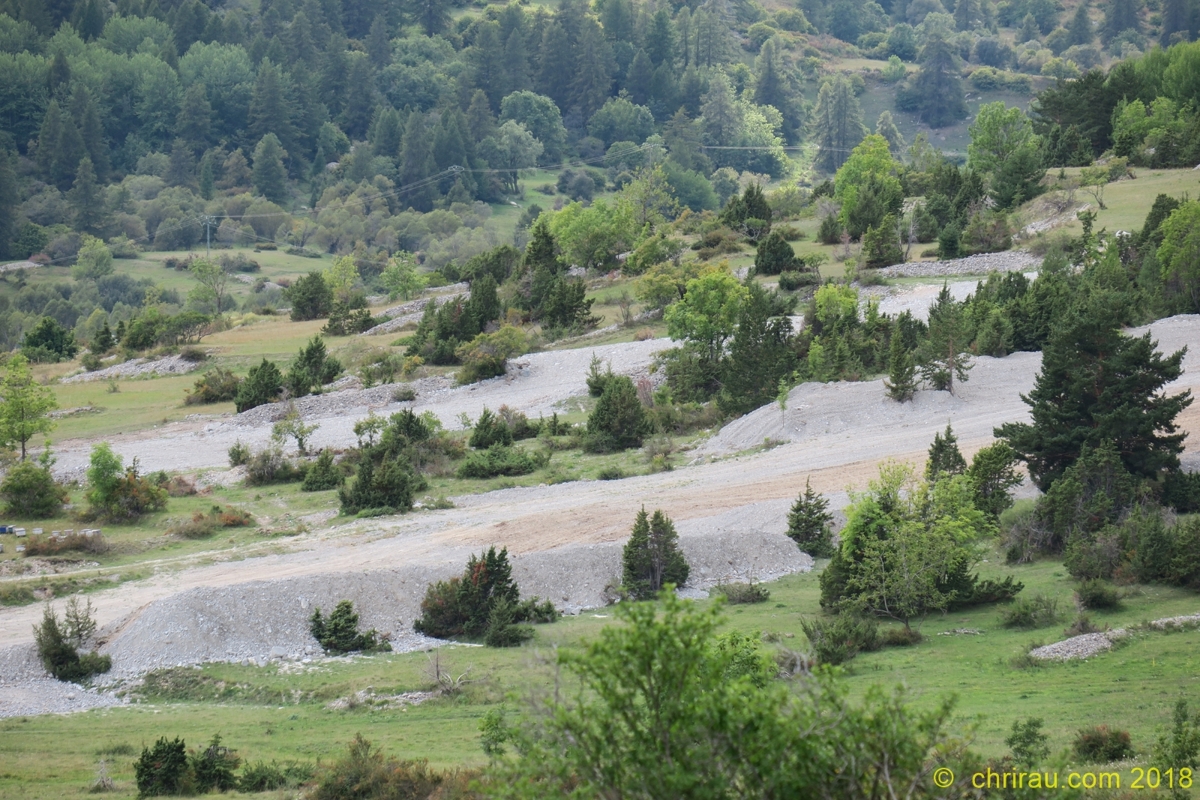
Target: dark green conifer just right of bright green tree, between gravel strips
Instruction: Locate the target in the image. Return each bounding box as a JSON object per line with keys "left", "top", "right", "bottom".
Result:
{"left": 718, "top": 281, "right": 796, "bottom": 415}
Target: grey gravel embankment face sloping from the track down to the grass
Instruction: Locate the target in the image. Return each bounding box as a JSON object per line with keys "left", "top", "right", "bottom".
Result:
{"left": 0, "top": 525, "right": 812, "bottom": 716}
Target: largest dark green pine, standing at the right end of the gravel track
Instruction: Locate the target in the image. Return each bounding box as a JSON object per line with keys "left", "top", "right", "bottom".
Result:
{"left": 996, "top": 291, "right": 1192, "bottom": 492}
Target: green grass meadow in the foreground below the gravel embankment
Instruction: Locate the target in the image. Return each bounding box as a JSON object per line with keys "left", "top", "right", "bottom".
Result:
{"left": 0, "top": 554, "right": 1200, "bottom": 799}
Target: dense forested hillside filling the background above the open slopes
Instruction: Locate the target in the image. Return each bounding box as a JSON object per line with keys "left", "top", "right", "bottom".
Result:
{"left": 0, "top": 0, "right": 1200, "bottom": 357}
